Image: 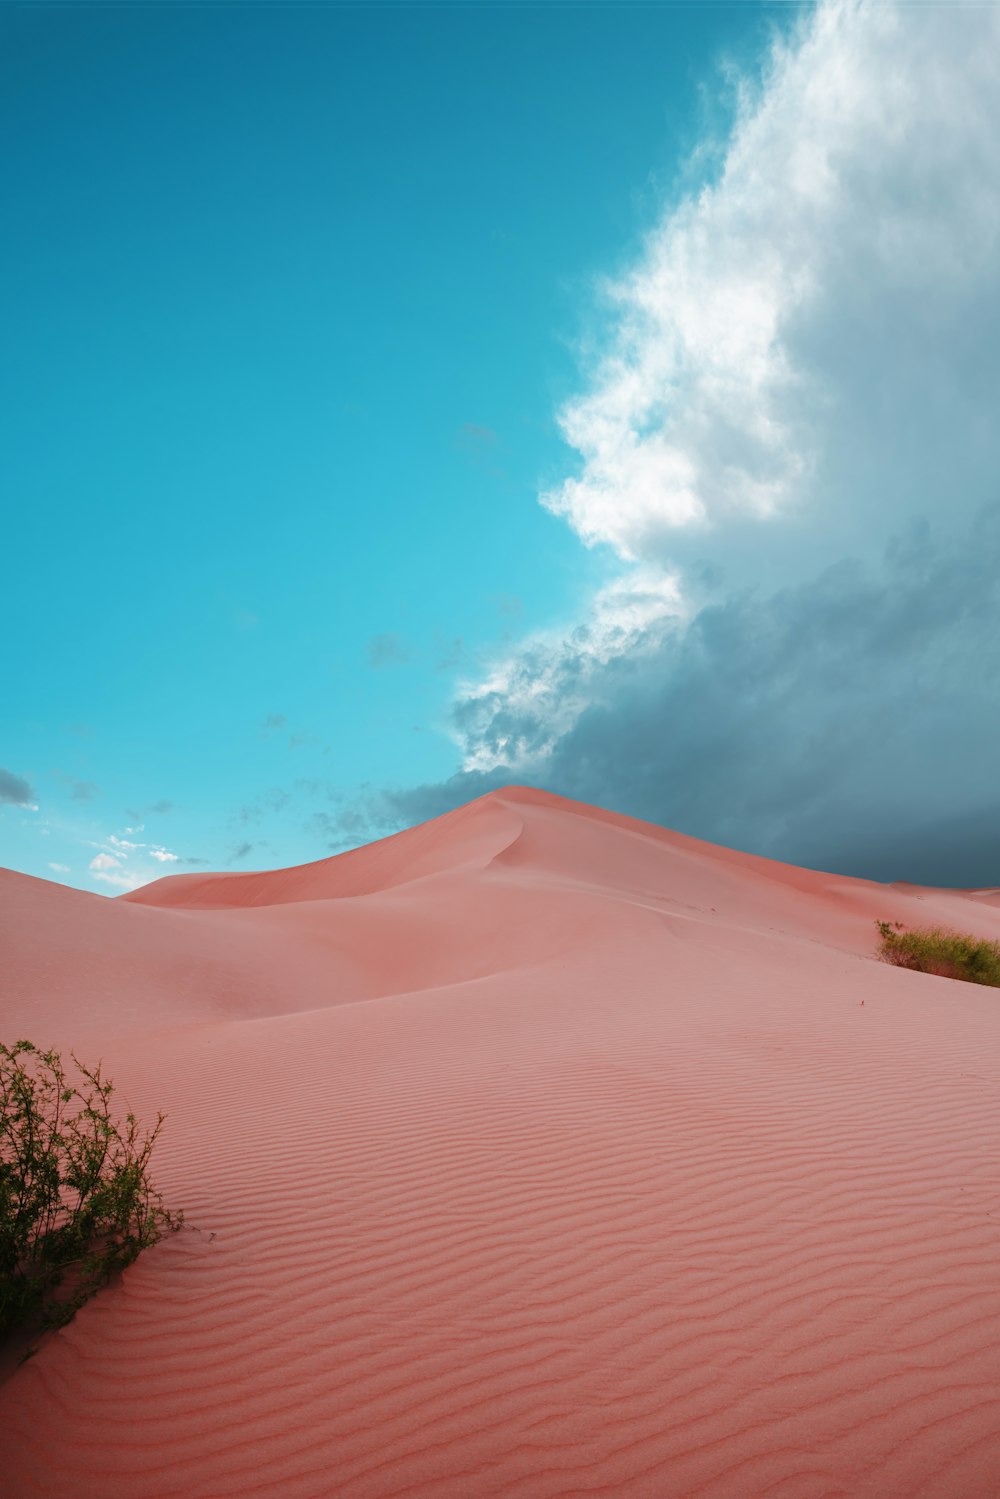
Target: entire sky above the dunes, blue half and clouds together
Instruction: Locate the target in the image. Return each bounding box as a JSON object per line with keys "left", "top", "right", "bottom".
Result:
{"left": 0, "top": 0, "right": 1000, "bottom": 895}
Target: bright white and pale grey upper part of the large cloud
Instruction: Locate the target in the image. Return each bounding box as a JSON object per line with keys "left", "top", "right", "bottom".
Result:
{"left": 454, "top": 0, "right": 1000, "bottom": 772}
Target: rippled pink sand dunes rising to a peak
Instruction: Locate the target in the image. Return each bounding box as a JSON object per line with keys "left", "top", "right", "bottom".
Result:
{"left": 0, "top": 787, "right": 1000, "bottom": 1499}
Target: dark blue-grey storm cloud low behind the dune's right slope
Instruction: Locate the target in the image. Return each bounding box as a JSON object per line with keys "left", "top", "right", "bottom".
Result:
{"left": 367, "top": 508, "right": 1000, "bottom": 886}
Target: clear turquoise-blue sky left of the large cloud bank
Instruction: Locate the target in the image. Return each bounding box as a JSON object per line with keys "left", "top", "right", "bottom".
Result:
{"left": 0, "top": 6, "right": 779, "bottom": 884}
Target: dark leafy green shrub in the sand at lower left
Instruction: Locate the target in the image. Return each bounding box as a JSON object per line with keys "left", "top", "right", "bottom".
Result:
{"left": 0, "top": 1040, "right": 183, "bottom": 1337}
